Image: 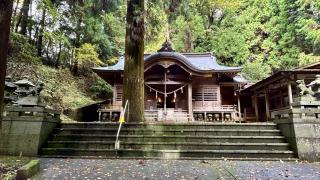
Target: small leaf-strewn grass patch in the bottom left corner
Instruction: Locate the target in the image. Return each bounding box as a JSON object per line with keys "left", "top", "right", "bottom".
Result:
{"left": 0, "top": 156, "right": 32, "bottom": 180}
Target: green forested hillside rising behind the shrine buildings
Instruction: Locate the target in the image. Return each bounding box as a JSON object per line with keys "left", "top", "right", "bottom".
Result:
{"left": 2, "top": 0, "right": 320, "bottom": 114}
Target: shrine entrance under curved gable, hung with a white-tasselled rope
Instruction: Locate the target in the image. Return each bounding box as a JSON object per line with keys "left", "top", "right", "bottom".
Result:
{"left": 145, "top": 64, "right": 190, "bottom": 122}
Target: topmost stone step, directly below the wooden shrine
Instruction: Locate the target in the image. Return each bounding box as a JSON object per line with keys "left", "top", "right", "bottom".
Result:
{"left": 60, "top": 122, "right": 277, "bottom": 130}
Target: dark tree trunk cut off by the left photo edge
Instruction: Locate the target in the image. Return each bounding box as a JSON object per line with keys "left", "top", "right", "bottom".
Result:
{"left": 0, "top": 0, "right": 13, "bottom": 127}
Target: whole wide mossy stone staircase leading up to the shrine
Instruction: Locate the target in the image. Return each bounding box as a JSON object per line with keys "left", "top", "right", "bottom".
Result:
{"left": 41, "top": 123, "right": 294, "bottom": 160}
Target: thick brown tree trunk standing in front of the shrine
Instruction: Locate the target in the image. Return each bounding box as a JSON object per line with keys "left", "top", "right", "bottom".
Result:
{"left": 122, "top": 0, "right": 145, "bottom": 122}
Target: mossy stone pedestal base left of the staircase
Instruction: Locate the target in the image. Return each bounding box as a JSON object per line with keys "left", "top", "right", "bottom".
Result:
{"left": 0, "top": 106, "right": 60, "bottom": 156}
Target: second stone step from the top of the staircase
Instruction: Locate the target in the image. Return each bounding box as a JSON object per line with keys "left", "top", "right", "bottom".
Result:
{"left": 55, "top": 128, "right": 281, "bottom": 136}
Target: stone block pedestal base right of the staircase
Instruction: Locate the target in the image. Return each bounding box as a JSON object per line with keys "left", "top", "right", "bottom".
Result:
{"left": 273, "top": 100, "right": 320, "bottom": 162}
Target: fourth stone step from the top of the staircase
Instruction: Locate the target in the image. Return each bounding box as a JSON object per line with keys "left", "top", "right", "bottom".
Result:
{"left": 47, "top": 141, "right": 289, "bottom": 151}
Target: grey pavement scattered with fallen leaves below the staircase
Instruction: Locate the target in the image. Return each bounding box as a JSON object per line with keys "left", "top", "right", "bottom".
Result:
{"left": 33, "top": 158, "right": 320, "bottom": 180}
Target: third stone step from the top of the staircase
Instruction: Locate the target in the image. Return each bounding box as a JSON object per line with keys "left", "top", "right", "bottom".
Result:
{"left": 52, "top": 134, "right": 285, "bottom": 143}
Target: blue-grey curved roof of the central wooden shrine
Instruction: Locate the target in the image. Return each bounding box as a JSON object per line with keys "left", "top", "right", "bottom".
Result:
{"left": 93, "top": 52, "right": 242, "bottom": 72}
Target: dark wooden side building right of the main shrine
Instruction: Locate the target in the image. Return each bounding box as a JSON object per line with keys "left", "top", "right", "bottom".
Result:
{"left": 239, "top": 62, "right": 320, "bottom": 122}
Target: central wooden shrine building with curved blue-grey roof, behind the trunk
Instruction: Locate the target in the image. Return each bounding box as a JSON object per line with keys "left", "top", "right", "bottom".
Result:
{"left": 94, "top": 42, "right": 247, "bottom": 122}
